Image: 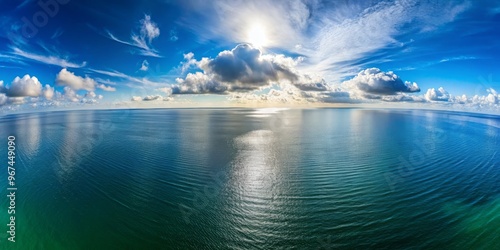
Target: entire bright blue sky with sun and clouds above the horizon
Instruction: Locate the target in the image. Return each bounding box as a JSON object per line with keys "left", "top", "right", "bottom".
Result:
{"left": 0, "top": 0, "right": 500, "bottom": 113}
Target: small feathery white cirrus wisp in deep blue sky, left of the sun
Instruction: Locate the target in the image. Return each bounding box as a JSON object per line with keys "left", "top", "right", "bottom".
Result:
{"left": 105, "top": 15, "right": 162, "bottom": 57}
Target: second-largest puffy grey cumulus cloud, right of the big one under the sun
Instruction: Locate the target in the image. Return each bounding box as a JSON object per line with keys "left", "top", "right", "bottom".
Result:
{"left": 343, "top": 68, "right": 420, "bottom": 95}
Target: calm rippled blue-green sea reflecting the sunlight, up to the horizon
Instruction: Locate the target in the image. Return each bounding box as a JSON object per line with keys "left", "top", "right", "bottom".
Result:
{"left": 0, "top": 109, "right": 500, "bottom": 249}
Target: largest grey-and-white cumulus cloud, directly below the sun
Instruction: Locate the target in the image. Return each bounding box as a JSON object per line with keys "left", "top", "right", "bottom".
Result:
{"left": 173, "top": 44, "right": 329, "bottom": 94}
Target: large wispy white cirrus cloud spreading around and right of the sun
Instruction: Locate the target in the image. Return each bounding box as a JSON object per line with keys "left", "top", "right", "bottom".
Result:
{"left": 180, "top": 0, "right": 470, "bottom": 83}
